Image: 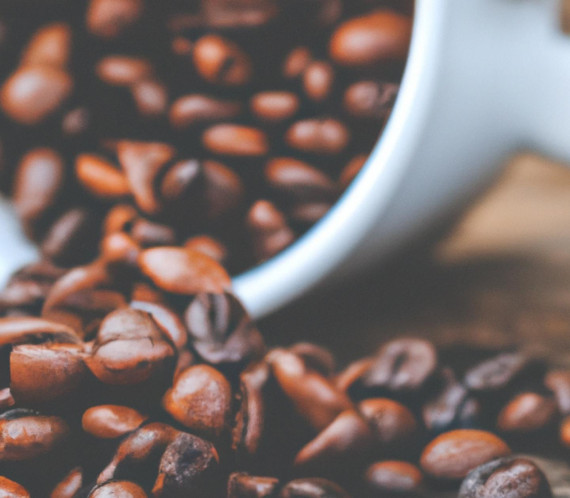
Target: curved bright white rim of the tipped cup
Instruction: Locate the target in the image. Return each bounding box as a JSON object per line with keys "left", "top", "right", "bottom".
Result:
{"left": 232, "top": 0, "right": 445, "bottom": 318}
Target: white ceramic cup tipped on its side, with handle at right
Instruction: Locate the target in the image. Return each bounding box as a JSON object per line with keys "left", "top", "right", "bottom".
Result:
{"left": 0, "top": 0, "right": 570, "bottom": 317}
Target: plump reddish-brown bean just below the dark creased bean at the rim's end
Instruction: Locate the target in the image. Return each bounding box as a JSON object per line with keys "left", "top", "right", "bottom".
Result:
{"left": 162, "top": 365, "right": 232, "bottom": 438}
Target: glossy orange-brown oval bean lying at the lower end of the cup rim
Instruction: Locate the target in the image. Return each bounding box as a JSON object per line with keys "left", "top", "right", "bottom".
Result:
{"left": 138, "top": 247, "right": 231, "bottom": 295}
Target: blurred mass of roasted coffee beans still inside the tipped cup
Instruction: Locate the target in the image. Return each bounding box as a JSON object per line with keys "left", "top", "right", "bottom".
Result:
{"left": 0, "top": 0, "right": 413, "bottom": 272}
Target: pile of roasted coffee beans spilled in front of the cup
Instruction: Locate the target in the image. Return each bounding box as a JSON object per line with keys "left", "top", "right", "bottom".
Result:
{"left": 0, "top": 251, "right": 570, "bottom": 498}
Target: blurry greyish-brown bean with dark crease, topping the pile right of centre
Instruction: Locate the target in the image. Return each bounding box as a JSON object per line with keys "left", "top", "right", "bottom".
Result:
{"left": 362, "top": 338, "right": 437, "bottom": 392}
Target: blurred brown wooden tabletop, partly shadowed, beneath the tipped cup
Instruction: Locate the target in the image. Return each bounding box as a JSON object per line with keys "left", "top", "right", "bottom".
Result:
{"left": 261, "top": 154, "right": 570, "bottom": 497}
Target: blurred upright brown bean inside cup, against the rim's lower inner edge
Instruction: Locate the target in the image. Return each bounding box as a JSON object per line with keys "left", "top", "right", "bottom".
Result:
{"left": 246, "top": 200, "right": 295, "bottom": 261}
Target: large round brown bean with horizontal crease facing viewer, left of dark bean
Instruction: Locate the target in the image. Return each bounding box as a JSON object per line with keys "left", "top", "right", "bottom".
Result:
{"left": 85, "top": 308, "right": 174, "bottom": 385}
